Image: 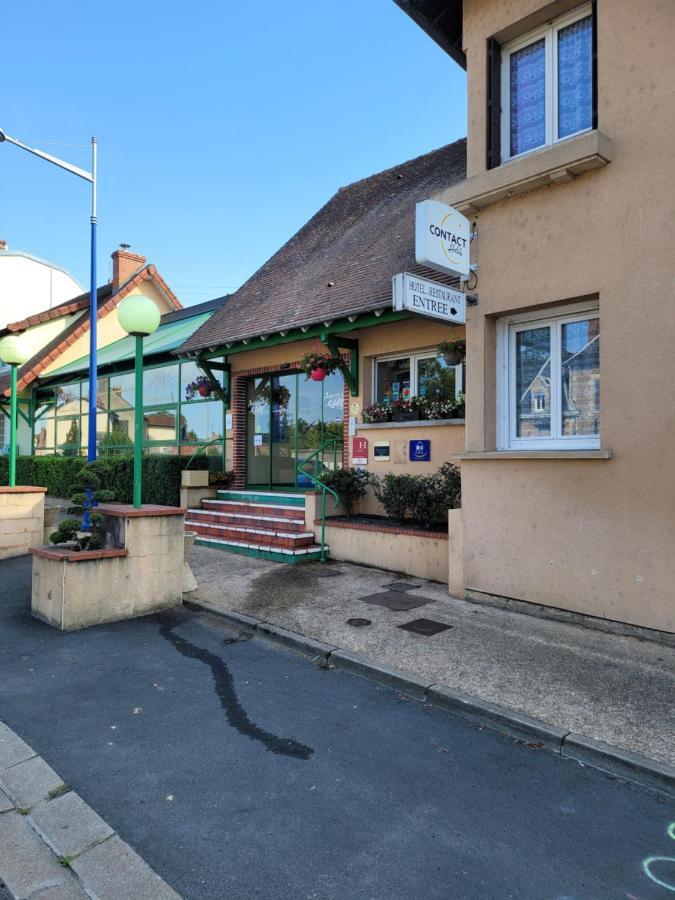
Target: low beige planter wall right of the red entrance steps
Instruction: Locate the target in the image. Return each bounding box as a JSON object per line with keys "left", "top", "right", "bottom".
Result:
{"left": 314, "top": 518, "right": 448, "bottom": 584}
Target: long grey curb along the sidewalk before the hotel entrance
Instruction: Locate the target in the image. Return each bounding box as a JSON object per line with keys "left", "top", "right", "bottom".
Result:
{"left": 184, "top": 597, "right": 675, "bottom": 797}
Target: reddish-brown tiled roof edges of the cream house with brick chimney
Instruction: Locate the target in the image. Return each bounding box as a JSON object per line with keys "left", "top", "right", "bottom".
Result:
{"left": 0, "top": 265, "right": 182, "bottom": 396}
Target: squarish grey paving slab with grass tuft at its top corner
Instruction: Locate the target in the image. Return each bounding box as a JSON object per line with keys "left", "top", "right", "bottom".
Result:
{"left": 29, "top": 791, "right": 113, "bottom": 856}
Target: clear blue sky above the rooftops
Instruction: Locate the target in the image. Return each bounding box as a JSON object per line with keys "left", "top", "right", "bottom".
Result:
{"left": 0, "top": 0, "right": 466, "bottom": 305}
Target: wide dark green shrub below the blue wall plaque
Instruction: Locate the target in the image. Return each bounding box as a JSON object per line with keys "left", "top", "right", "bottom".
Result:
{"left": 371, "top": 463, "right": 462, "bottom": 530}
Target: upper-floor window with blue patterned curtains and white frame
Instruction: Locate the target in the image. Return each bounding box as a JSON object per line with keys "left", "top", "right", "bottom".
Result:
{"left": 501, "top": 3, "right": 593, "bottom": 162}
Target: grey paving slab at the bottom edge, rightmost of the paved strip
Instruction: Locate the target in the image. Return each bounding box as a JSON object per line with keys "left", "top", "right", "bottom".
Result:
{"left": 72, "top": 835, "right": 180, "bottom": 900}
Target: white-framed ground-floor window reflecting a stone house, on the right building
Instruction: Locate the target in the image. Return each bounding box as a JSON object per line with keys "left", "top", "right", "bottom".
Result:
{"left": 498, "top": 307, "right": 600, "bottom": 449}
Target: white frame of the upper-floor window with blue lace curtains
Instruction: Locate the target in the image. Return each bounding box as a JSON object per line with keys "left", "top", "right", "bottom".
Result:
{"left": 501, "top": 3, "right": 593, "bottom": 163}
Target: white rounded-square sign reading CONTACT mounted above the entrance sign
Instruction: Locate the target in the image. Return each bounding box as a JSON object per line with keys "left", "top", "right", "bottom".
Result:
{"left": 415, "top": 200, "right": 471, "bottom": 278}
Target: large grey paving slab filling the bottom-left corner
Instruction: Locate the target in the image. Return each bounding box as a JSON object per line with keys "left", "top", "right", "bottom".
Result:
{"left": 0, "top": 812, "right": 82, "bottom": 900}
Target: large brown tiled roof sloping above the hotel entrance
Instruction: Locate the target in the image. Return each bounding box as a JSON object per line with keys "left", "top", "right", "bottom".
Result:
{"left": 178, "top": 140, "right": 466, "bottom": 353}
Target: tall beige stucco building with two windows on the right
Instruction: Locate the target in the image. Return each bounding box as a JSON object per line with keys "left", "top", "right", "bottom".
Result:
{"left": 400, "top": 0, "right": 675, "bottom": 632}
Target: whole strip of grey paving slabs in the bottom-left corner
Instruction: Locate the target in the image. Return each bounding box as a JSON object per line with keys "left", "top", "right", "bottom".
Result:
{"left": 0, "top": 721, "right": 181, "bottom": 900}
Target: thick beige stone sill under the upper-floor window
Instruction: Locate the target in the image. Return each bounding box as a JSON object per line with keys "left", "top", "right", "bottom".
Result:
{"left": 436, "top": 130, "right": 612, "bottom": 215}
